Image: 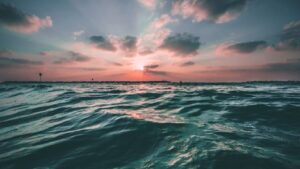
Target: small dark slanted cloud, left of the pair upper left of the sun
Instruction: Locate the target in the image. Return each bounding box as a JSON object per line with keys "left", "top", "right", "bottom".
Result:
{"left": 90, "top": 36, "right": 116, "bottom": 51}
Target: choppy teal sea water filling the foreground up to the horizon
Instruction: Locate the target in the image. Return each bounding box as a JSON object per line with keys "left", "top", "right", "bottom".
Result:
{"left": 0, "top": 82, "right": 300, "bottom": 169}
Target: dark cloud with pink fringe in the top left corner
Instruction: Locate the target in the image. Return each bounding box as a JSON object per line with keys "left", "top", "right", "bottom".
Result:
{"left": 0, "top": 3, "right": 53, "bottom": 33}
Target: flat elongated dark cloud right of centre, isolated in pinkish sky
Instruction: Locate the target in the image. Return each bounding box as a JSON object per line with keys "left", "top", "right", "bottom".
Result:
{"left": 226, "top": 41, "right": 268, "bottom": 53}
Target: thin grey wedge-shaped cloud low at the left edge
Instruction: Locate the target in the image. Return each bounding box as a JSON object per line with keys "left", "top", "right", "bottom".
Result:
{"left": 0, "top": 56, "right": 43, "bottom": 67}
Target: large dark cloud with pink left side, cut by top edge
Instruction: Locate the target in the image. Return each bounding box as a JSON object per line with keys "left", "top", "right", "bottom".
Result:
{"left": 172, "top": 0, "right": 247, "bottom": 23}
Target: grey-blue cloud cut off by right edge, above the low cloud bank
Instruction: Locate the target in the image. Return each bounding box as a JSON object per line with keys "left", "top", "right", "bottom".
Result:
{"left": 273, "top": 20, "right": 300, "bottom": 51}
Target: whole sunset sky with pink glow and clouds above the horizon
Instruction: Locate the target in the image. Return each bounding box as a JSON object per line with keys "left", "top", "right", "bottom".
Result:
{"left": 0, "top": 0, "right": 300, "bottom": 82}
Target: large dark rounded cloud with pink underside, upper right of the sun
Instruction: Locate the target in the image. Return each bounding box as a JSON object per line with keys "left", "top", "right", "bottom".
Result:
{"left": 160, "top": 33, "right": 201, "bottom": 57}
